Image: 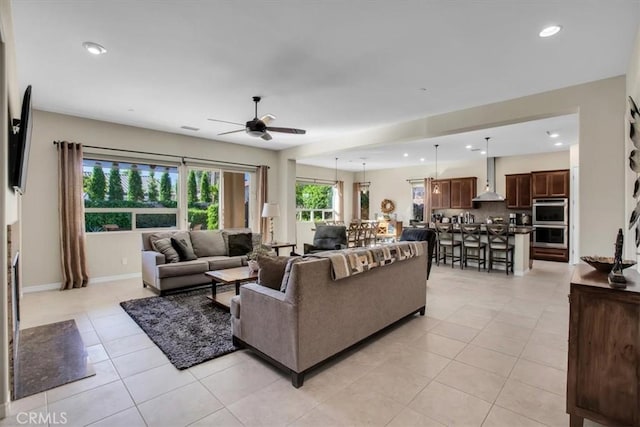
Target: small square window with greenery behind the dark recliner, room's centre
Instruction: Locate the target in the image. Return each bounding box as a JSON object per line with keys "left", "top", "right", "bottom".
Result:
{"left": 296, "top": 182, "right": 335, "bottom": 222}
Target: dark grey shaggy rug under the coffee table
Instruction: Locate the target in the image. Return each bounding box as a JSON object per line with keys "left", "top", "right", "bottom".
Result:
{"left": 120, "top": 288, "right": 237, "bottom": 369}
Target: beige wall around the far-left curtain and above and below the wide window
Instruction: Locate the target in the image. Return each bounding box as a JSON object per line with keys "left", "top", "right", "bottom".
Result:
{"left": 22, "top": 110, "right": 278, "bottom": 287}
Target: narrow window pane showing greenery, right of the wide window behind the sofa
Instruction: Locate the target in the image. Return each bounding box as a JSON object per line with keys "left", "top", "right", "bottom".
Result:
{"left": 187, "top": 168, "right": 220, "bottom": 230}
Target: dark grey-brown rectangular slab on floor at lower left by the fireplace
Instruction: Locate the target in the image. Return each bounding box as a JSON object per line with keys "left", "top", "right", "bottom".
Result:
{"left": 14, "top": 320, "right": 96, "bottom": 399}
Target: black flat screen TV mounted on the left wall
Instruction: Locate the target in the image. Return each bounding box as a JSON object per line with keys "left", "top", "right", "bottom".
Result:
{"left": 8, "top": 85, "right": 32, "bottom": 194}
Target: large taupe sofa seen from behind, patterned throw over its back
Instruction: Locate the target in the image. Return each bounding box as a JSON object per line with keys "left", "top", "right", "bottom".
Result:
{"left": 231, "top": 242, "right": 427, "bottom": 388}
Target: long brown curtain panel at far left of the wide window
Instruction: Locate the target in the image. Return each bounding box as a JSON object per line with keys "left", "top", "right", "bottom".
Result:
{"left": 57, "top": 141, "right": 89, "bottom": 290}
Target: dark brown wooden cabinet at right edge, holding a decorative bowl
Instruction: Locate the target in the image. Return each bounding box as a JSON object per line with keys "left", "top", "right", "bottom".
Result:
{"left": 567, "top": 264, "right": 640, "bottom": 427}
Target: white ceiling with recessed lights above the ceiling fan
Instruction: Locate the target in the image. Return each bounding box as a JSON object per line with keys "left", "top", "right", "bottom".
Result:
{"left": 13, "top": 0, "right": 640, "bottom": 170}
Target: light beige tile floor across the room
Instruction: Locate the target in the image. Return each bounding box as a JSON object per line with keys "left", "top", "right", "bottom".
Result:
{"left": 0, "top": 261, "right": 594, "bottom": 427}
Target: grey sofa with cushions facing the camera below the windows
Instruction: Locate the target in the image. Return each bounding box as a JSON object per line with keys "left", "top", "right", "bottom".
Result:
{"left": 141, "top": 228, "right": 262, "bottom": 295}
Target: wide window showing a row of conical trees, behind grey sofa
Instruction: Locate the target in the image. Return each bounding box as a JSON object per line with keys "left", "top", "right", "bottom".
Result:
{"left": 83, "top": 158, "right": 179, "bottom": 232}
